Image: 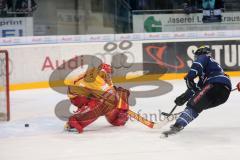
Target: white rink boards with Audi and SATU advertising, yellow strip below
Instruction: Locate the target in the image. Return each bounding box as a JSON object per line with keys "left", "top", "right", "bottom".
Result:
{"left": 0, "top": 31, "right": 240, "bottom": 90}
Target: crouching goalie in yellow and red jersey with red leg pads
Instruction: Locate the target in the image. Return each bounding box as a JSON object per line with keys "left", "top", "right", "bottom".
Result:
{"left": 65, "top": 64, "right": 129, "bottom": 133}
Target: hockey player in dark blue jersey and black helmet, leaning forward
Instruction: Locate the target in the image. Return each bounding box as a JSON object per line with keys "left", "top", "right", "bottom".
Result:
{"left": 163, "top": 46, "right": 232, "bottom": 136}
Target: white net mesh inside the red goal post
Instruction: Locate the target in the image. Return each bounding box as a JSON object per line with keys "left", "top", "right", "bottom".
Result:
{"left": 0, "top": 51, "right": 8, "bottom": 121}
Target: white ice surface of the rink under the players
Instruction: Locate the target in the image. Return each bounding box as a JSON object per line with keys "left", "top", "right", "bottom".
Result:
{"left": 0, "top": 78, "right": 240, "bottom": 160}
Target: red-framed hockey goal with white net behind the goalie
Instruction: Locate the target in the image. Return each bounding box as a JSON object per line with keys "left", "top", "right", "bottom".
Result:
{"left": 0, "top": 50, "right": 10, "bottom": 121}
